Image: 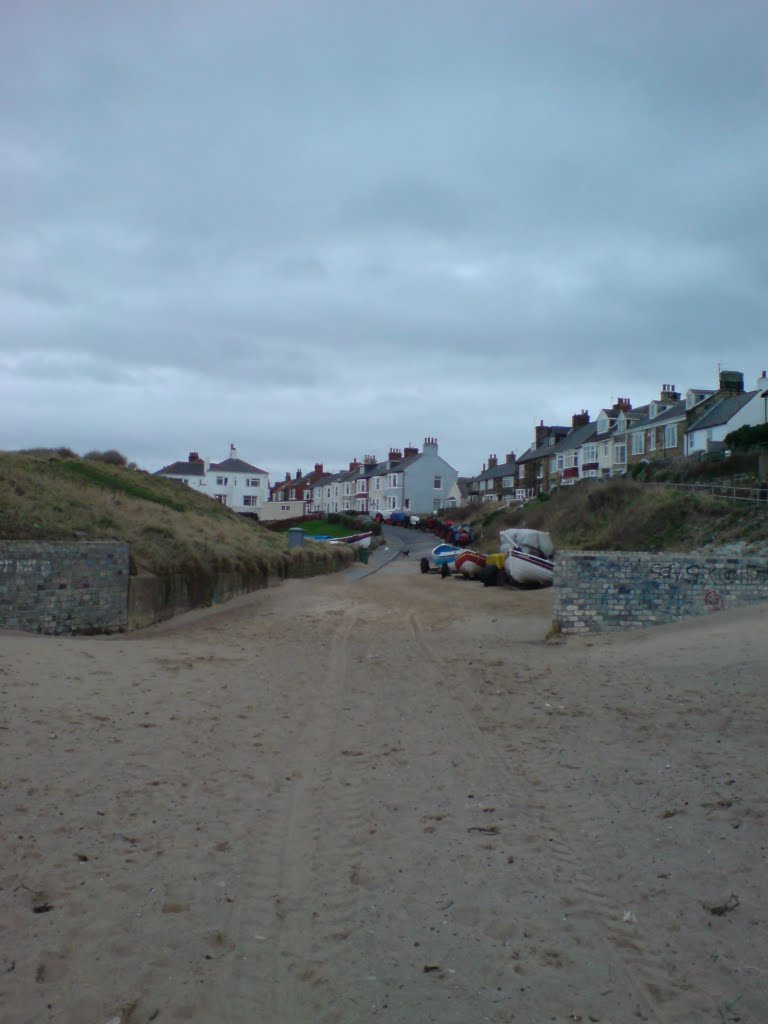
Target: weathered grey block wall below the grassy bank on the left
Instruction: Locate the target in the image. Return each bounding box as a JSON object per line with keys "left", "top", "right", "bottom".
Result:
{"left": 0, "top": 541, "right": 128, "bottom": 633}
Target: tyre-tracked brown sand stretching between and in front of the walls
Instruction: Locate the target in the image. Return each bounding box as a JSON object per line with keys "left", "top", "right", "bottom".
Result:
{"left": 0, "top": 558, "right": 768, "bottom": 1024}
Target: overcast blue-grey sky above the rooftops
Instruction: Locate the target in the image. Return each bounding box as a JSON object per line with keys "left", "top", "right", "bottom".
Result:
{"left": 0, "top": 0, "right": 768, "bottom": 478}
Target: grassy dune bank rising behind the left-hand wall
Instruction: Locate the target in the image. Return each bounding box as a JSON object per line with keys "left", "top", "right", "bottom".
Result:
{"left": 0, "top": 452, "right": 349, "bottom": 579}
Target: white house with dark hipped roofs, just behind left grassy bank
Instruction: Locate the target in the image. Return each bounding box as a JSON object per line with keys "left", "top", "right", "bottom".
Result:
{"left": 155, "top": 444, "right": 269, "bottom": 514}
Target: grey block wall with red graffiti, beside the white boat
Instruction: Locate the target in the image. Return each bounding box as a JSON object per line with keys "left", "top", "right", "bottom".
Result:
{"left": 553, "top": 551, "right": 768, "bottom": 633}
